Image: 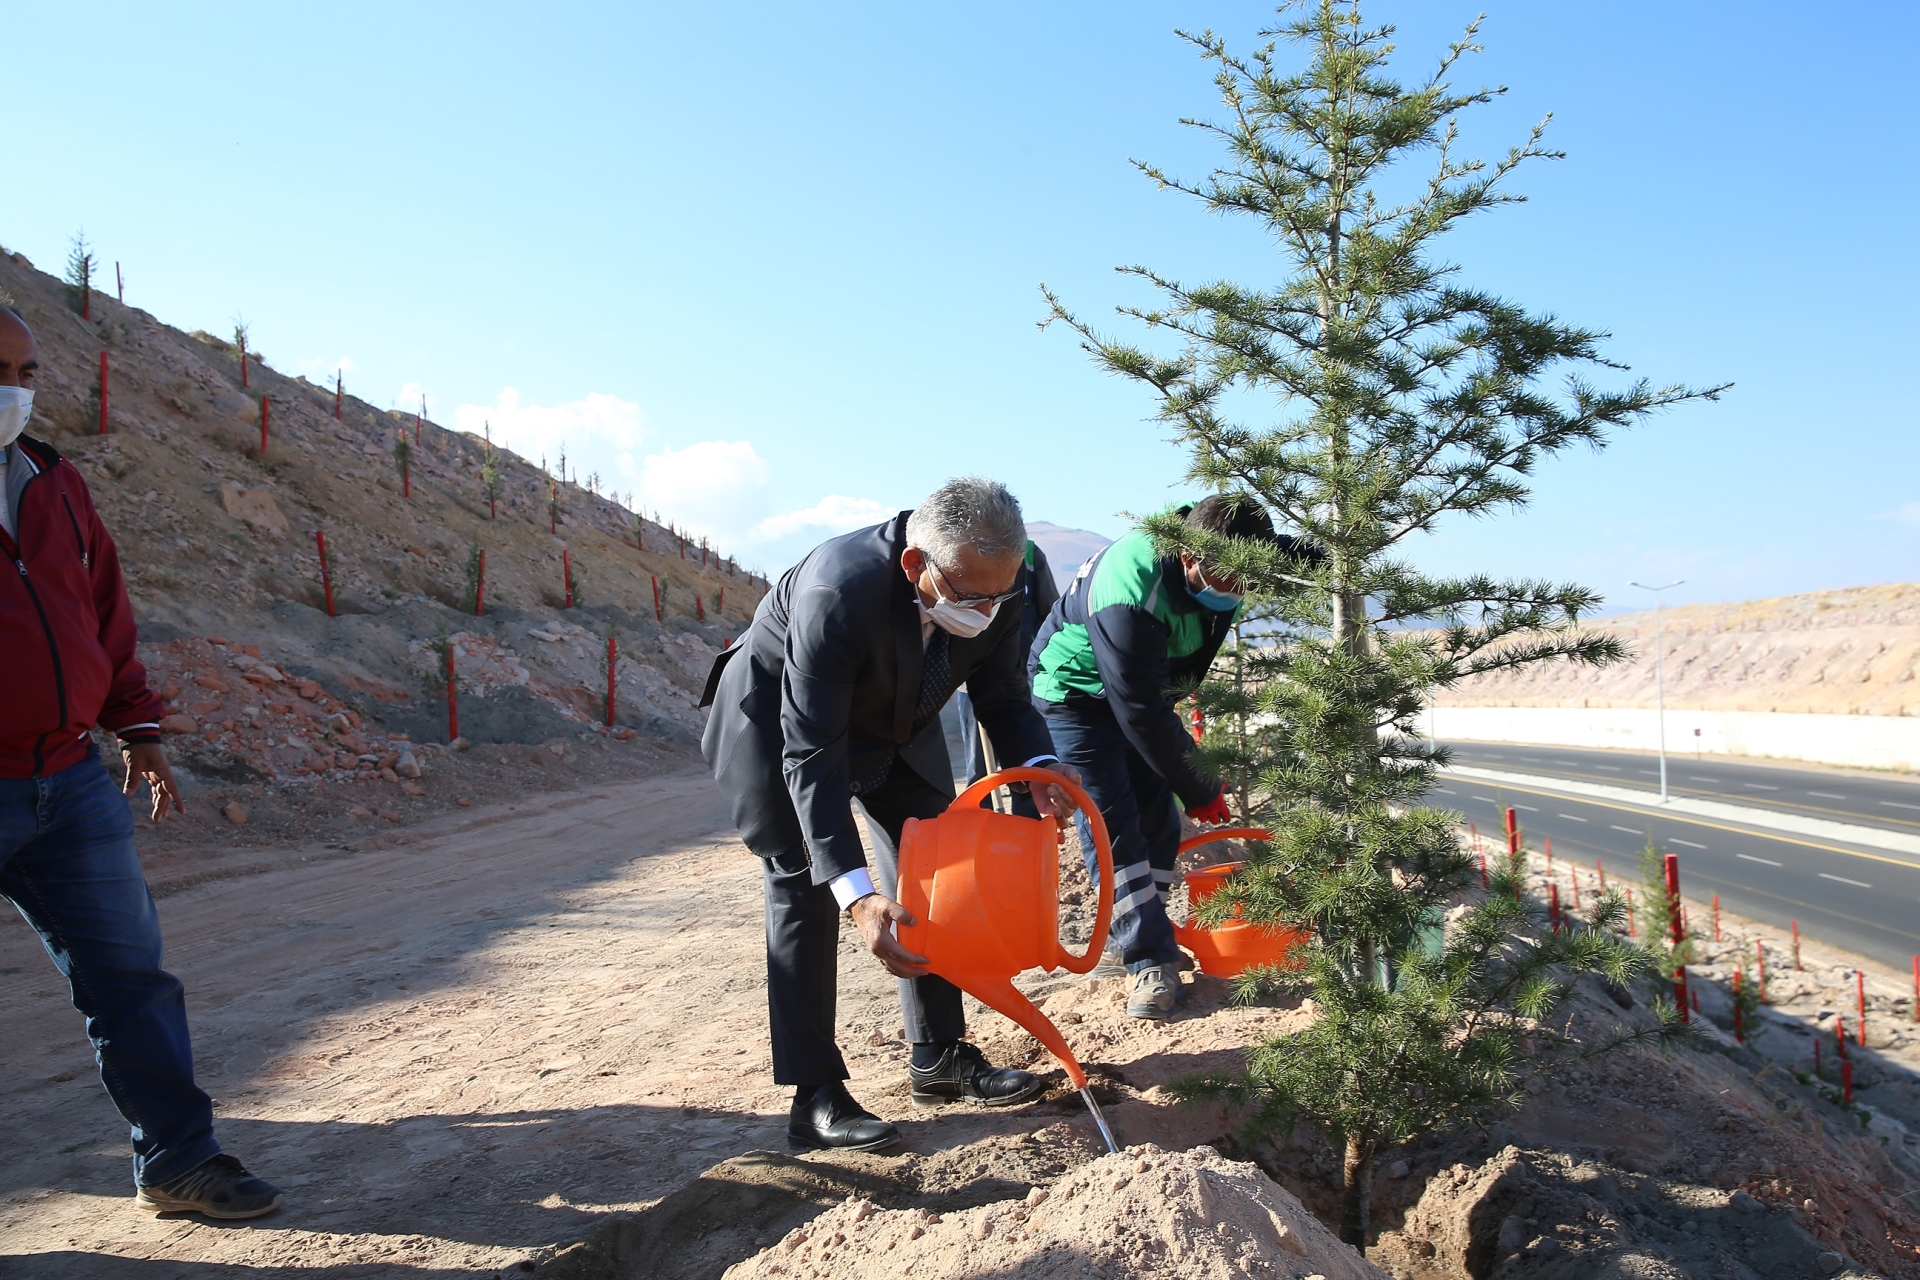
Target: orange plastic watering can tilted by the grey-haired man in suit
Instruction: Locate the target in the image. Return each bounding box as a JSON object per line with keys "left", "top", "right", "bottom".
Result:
{"left": 897, "top": 770, "right": 1119, "bottom": 1151}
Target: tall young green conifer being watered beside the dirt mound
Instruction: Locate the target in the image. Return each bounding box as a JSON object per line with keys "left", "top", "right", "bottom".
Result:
{"left": 1046, "top": 0, "right": 1724, "bottom": 1244}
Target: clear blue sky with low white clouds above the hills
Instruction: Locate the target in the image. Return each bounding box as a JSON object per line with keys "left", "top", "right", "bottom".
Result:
{"left": 0, "top": 0, "right": 1920, "bottom": 608}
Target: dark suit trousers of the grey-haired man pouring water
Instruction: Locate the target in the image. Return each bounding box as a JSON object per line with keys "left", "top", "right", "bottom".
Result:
{"left": 762, "top": 762, "right": 966, "bottom": 1084}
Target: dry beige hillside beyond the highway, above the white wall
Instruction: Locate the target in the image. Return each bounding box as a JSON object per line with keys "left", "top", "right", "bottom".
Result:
{"left": 1440, "top": 583, "right": 1920, "bottom": 716}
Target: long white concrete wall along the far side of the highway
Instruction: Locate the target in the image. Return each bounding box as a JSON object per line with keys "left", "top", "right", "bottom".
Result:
{"left": 1421, "top": 706, "right": 1920, "bottom": 771}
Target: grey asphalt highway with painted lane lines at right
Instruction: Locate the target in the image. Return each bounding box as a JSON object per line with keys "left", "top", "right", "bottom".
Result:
{"left": 1434, "top": 743, "right": 1920, "bottom": 971}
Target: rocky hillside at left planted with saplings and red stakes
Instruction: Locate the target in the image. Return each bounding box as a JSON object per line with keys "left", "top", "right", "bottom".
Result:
{"left": 0, "top": 249, "right": 762, "bottom": 852}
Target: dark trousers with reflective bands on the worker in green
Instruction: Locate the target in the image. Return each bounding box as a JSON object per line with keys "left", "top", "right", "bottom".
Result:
{"left": 1039, "top": 699, "right": 1181, "bottom": 973}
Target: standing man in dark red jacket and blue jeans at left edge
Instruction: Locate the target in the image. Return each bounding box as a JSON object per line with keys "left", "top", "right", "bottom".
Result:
{"left": 0, "top": 307, "right": 280, "bottom": 1219}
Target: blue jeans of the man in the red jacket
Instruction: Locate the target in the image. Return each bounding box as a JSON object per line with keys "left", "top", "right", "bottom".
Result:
{"left": 0, "top": 750, "right": 221, "bottom": 1186}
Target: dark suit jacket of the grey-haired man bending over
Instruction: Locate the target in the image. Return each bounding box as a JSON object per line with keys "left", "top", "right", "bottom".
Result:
{"left": 701, "top": 510, "right": 1054, "bottom": 885}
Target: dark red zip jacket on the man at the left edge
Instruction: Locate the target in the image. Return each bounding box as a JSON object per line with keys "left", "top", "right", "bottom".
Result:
{"left": 0, "top": 436, "right": 165, "bottom": 777}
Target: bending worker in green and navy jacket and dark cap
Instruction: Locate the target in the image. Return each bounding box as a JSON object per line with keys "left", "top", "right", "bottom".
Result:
{"left": 1027, "top": 495, "right": 1317, "bottom": 1019}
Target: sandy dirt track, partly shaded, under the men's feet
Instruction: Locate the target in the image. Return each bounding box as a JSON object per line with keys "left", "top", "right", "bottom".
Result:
{"left": 0, "top": 771, "right": 1298, "bottom": 1280}
